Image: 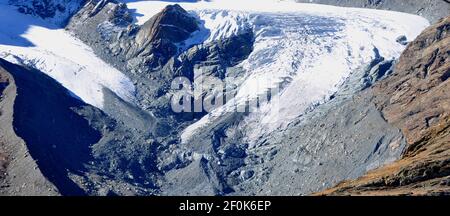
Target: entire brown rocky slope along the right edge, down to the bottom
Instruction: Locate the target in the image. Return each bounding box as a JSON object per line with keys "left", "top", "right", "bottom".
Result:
{"left": 319, "top": 17, "right": 450, "bottom": 195}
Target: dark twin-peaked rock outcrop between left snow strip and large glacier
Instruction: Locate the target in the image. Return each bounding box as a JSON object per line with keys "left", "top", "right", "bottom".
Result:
{"left": 67, "top": 0, "right": 199, "bottom": 70}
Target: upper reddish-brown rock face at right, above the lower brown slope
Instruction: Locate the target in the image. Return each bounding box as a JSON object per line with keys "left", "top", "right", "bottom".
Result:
{"left": 374, "top": 17, "right": 450, "bottom": 147}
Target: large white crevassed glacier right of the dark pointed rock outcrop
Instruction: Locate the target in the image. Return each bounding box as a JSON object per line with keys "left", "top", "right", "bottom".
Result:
{"left": 119, "top": 0, "right": 429, "bottom": 143}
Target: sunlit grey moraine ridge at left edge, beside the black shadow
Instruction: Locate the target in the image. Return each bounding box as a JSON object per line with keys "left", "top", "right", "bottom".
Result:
{"left": 0, "top": 60, "right": 59, "bottom": 196}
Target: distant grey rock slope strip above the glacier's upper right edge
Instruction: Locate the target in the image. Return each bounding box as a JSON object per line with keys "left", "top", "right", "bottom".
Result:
{"left": 296, "top": 0, "right": 450, "bottom": 23}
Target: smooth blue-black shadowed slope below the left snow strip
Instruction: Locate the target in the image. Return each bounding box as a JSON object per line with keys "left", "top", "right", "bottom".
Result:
{"left": 1, "top": 60, "right": 100, "bottom": 195}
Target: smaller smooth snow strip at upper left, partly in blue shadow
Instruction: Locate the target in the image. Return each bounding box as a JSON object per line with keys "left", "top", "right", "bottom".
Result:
{"left": 0, "top": 0, "right": 134, "bottom": 108}
